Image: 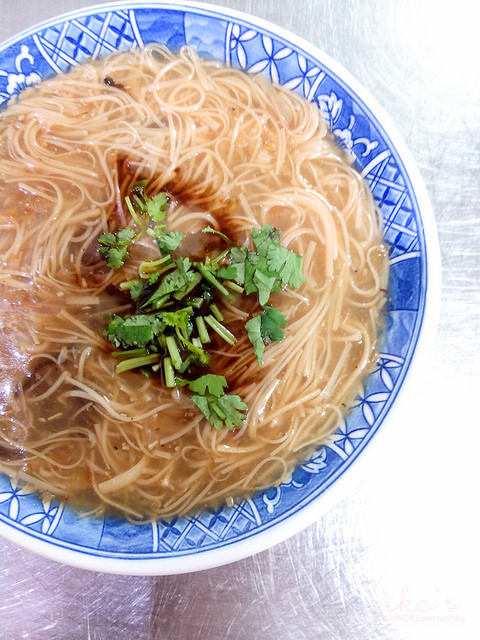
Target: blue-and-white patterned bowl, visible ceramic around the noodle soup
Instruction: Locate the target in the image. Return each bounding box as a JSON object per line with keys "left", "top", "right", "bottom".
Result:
{"left": 0, "top": 1, "right": 440, "bottom": 575}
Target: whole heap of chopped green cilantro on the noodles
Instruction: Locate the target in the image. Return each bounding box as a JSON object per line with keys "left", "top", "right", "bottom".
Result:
{"left": 99, "top": 180, "right": 305, "bottom": 429}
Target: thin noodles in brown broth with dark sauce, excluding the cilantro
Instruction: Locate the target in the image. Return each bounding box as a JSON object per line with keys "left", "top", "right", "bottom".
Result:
{"left": 0, "top": 46, "right": 388, "bottom": 520}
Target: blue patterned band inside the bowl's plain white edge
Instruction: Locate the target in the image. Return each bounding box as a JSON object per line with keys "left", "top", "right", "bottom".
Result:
{"left": 0, "top": 3, "right": 427, "bottom": 559}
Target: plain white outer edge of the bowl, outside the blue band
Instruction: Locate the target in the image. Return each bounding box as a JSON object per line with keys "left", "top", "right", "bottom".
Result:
{"left": 0, "top": 0, "right": 441, "bottom": 576}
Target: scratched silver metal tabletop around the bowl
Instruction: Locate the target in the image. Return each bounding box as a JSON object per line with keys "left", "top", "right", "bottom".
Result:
{"left": 0, "top": 0, "right": 480, "bottom": 640}
